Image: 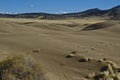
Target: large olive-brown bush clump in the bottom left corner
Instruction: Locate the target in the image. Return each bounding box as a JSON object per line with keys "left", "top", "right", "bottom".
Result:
{"left": 0, "top": 56, "right": 46, "bottom": 80}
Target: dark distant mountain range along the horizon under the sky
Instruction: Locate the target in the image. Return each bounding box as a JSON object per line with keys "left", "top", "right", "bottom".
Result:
{"left": 0, "top": 5, "right": 120, "bottom": 19}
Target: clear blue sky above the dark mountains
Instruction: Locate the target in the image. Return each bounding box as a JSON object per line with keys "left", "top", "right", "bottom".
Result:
{"left": 0, "top": 0, "right": 120, "bottom": 14}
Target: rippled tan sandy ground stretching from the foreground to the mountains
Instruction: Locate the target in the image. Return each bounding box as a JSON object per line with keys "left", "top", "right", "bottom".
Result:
{"left": 0, "top": 18, "right": 120, "bottom": 80}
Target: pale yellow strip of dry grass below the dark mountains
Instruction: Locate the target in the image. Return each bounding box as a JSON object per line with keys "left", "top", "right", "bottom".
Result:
{"left": 0, "top": 18, "right": 105, "bottom": 24}
